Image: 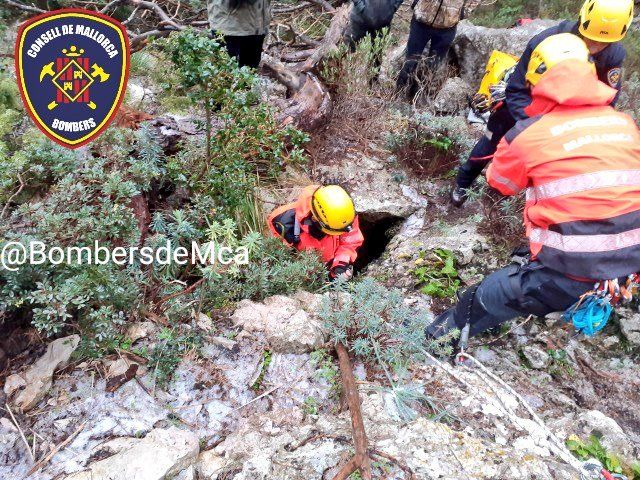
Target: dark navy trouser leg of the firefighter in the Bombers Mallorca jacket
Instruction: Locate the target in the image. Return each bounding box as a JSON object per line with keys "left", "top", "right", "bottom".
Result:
{"left": 427, "top": 261, "right": 593, "bottom": 337}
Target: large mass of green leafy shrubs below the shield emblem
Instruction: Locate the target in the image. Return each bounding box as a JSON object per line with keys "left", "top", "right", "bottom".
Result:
{"left": 0, "top": 31, "right": 326, "bottom": 364}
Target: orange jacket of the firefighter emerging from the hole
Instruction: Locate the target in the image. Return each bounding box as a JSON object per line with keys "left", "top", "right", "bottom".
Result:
{"left": 267, "top": 185, "right": 364, "bottom": 267}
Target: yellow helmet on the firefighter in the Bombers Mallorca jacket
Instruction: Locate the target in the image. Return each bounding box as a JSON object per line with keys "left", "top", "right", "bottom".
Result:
{"left": 525, "top": 33, "right": 596, "bottom": 85}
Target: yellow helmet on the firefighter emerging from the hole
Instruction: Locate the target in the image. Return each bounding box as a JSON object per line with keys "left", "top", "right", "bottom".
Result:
{"left": 311, "top": 185, "right": 356, "bottom": 235}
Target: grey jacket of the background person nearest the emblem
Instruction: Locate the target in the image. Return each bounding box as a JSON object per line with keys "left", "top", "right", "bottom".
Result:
{"left": 207, "top": 0, "right": 271, "bottom": 37}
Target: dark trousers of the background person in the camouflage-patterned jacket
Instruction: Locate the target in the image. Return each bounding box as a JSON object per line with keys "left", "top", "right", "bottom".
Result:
{"left": 397, "top": 17, "right": 458, "bottom": 89}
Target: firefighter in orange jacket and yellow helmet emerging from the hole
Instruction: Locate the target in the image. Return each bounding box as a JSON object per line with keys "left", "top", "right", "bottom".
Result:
{"left": 268, "top": 185, "right": 364, "bottom": 280}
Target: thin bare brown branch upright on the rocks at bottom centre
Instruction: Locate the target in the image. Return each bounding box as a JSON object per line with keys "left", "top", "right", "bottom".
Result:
{"left": 333, "top": 343, "right": 372, "bottom": 480}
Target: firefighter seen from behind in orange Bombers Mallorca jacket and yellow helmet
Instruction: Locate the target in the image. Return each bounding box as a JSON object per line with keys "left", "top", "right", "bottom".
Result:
{"left": 427, "top": 35, "right": 640, "bottom": 337}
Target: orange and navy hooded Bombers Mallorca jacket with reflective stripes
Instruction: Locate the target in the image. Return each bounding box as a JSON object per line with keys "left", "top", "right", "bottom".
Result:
{"left": 487, "top": 61, "right": 640, "bottom": 279}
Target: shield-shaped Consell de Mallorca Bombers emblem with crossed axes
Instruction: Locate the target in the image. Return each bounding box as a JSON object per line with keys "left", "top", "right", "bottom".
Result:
{"left": 15, "top": 8, "right": 130, "bottom": 148}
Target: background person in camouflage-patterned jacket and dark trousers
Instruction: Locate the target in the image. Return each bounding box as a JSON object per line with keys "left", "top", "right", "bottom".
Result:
{"left": 397, "top": 0, "right": 480, "bottom": 98}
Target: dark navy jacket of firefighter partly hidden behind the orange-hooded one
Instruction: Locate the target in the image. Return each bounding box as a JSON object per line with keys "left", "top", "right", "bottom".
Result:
{"left": 506, "top": 20, "right": 627, "bottom": 121}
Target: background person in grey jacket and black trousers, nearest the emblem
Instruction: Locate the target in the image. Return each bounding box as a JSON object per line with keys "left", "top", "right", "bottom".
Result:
{"left": 208, "top": 0, "right": 271, "bottom": 68}
